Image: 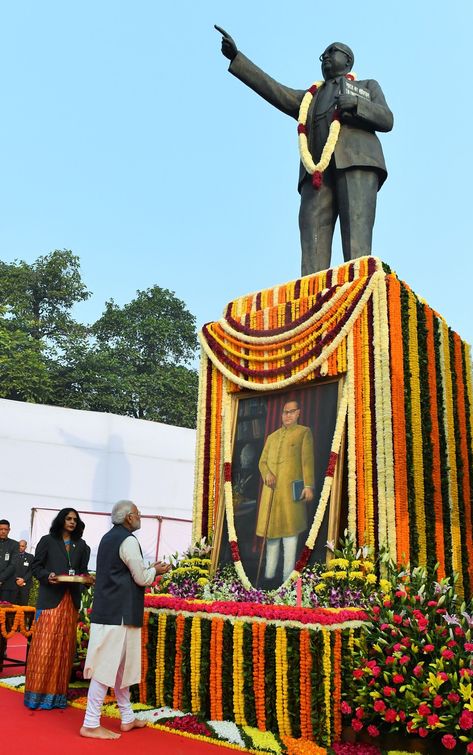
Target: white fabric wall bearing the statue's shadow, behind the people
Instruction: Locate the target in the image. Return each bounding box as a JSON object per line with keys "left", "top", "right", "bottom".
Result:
{"left": 0, "top": 399, "right": 195, "bottom": 558}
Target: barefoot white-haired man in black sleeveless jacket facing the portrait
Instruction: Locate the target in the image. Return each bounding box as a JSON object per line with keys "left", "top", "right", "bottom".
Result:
{"left": 80, "top": 501, "right": 169, "bottom": 739}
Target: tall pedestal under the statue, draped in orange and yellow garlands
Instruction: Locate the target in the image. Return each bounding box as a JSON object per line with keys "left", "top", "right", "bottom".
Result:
{"left": 193, "top": 257, "right": 473, "bottom": 597}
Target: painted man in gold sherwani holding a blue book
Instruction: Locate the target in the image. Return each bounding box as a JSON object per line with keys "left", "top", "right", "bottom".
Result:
{"left": 256, "top": 401, "right": 314, "bottom": 581}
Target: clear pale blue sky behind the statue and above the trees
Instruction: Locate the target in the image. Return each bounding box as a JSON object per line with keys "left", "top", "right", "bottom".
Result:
{"left": 0, "top": 0, "right": 473, "bottom": 343}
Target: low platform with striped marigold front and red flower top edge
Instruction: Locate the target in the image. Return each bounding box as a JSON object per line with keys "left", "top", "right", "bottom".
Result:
{"left": 140, "top": 595, "right": 367, "bottom": 745}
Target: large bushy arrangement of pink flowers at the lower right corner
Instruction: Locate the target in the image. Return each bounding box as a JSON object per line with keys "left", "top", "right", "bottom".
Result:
{"left": 345, "top": 568, "right": 473, "bottom": 753}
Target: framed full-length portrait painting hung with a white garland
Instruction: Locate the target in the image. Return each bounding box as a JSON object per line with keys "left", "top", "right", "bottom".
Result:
{"left": 212, "top": 378, "right": 343, "bottom": 590}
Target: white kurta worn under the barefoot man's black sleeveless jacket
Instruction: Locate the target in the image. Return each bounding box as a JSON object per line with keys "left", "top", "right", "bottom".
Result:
{"left": 84, "top": 536, "right": 156, "bottom": 687}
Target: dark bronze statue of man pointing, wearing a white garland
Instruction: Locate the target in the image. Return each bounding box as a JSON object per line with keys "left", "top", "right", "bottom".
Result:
{"left": 215, "top": 26, "right": 393, "bottom": 275}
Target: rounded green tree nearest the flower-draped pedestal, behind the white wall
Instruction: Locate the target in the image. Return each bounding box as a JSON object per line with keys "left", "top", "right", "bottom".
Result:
{"left": 58, "top": 286, "right": 198, "bottom": 427}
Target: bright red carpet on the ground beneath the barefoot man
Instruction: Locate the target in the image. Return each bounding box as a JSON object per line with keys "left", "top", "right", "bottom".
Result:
{"left": 0, "top": 635, "right": 251, "bottom": 755}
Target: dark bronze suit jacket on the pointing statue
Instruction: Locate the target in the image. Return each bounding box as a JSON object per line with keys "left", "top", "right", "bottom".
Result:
{"left": 229, "top": 52, "right": 393, "bottom": 190}
